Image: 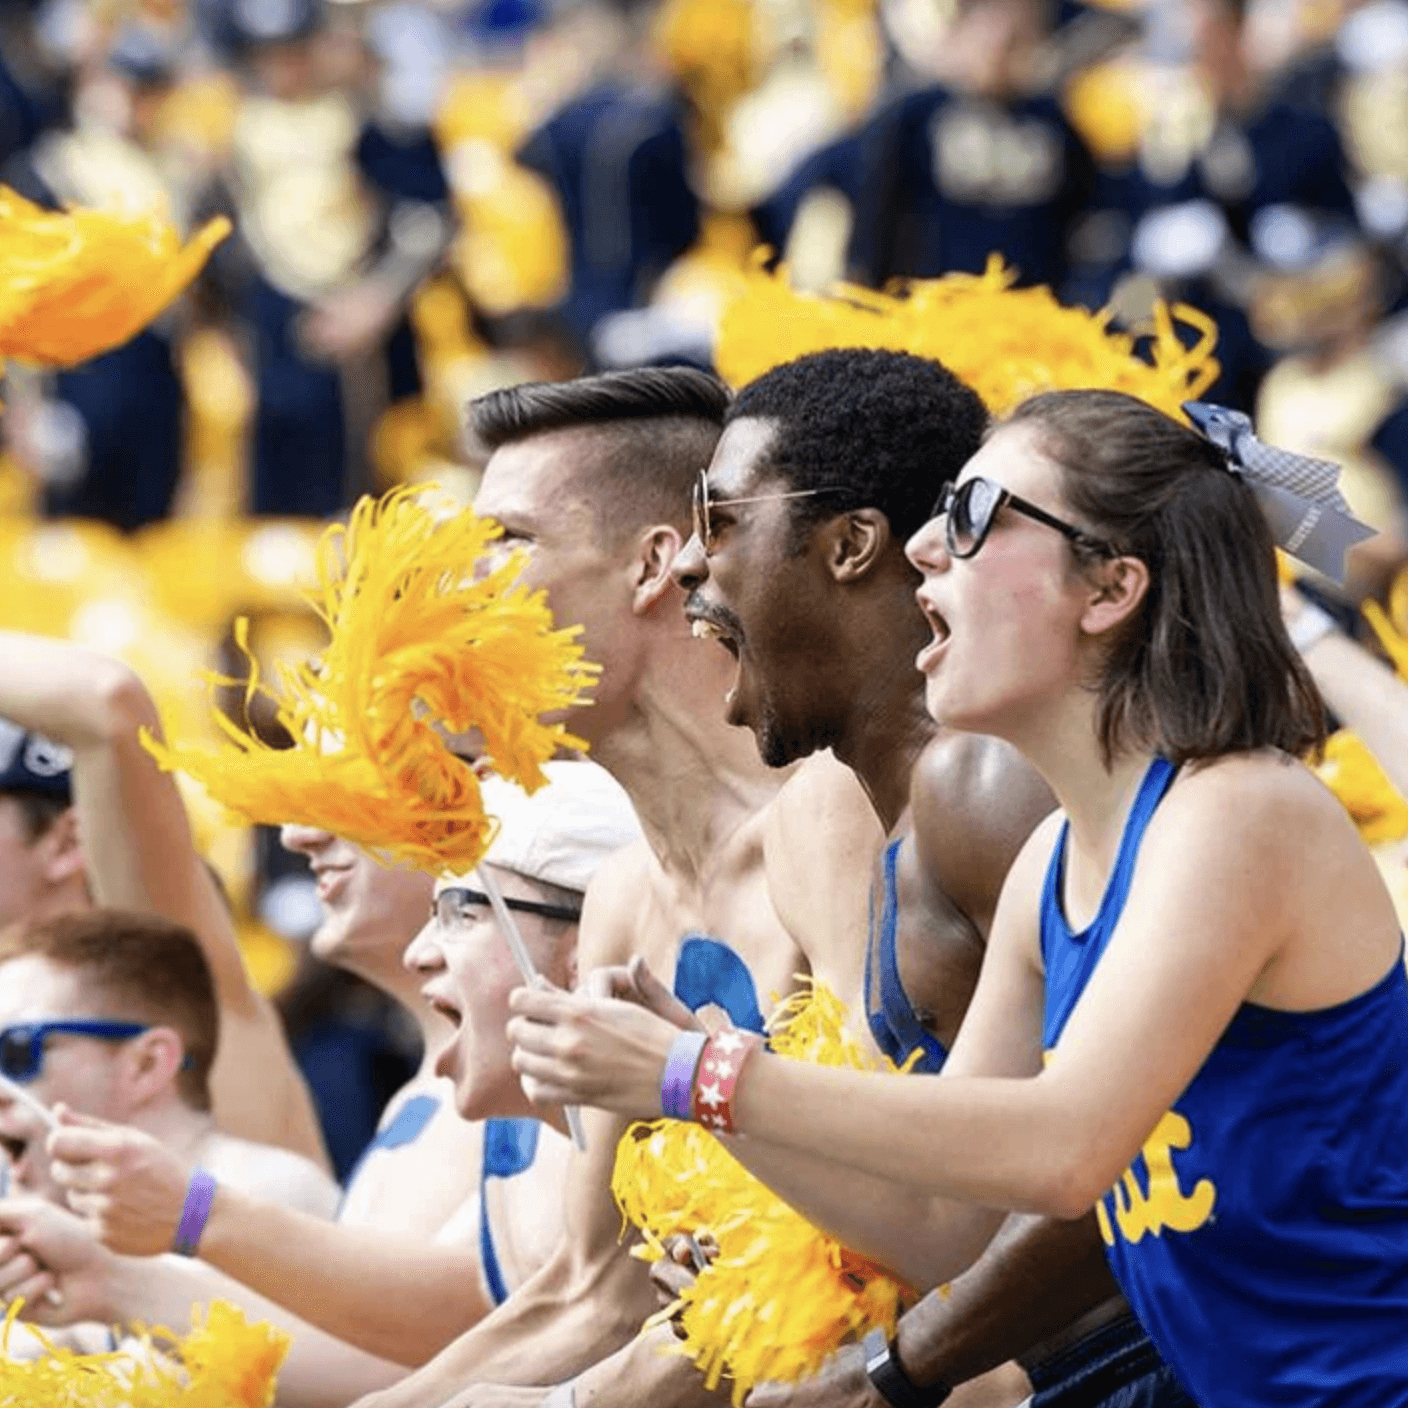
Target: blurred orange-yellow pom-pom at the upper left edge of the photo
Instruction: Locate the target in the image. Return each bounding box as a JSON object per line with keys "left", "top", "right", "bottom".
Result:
{"left": 0, "top": 186, "right": 231, "bottom": 366}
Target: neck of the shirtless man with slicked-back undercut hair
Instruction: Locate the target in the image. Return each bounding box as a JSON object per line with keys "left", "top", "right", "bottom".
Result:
{"left": 591, "top": 635, "right": 786, "bottom": 877}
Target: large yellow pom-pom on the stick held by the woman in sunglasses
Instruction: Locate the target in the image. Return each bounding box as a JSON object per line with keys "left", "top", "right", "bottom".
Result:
{"left": 142, "top": 489, "right": 597, "bottom": 873}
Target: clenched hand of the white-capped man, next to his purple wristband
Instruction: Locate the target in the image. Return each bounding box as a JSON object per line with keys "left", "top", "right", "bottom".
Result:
{"left": 48, "top": 1105, "right": 191, "bottom": 1256}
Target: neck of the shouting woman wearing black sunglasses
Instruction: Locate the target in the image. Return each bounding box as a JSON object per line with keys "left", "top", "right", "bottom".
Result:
{"left": 1004, "top": 689, "right": 1152, "bottom": 865}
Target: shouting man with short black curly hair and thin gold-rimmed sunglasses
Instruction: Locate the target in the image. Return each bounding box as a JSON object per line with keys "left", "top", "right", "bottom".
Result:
{"left": 674, "top": 351, "right": 1188, "bottom": 1408}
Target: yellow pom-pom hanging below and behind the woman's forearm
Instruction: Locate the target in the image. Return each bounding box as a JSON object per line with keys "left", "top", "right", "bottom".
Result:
{"left": 611, "top": 981, "right": 911, "bottom": 1404}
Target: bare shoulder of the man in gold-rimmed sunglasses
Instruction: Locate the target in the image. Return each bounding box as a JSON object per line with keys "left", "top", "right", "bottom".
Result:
{"left": 910, "top": 734, "right": 1056, "bottom": 931}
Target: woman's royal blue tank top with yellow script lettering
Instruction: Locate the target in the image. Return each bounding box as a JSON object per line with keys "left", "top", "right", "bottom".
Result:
{"left": 1041, "top": 759, "right": 1408, "bottom": 1408}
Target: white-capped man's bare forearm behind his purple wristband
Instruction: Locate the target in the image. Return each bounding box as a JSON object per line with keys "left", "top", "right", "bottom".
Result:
{"left": 200, "top": 1187, "right": 490, "bottom": 1366}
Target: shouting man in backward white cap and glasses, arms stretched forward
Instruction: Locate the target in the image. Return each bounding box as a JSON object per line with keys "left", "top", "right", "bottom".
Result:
{"left": 0, "top": 762, "right": 639, "bottom": 1408}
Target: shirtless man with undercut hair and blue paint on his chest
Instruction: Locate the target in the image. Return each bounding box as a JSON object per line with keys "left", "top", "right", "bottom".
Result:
{"left": 347, "top": 367, "right": 880, "bottom": 1408}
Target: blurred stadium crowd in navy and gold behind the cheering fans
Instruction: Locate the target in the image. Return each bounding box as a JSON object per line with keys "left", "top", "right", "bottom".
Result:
{"left": 0, "top": 0, "right": 1408, "bottom": 1173}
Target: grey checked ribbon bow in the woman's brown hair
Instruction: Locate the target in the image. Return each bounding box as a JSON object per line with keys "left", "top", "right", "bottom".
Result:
{"left": 1183, "top": 401, "right": 1374, "bottom": 582}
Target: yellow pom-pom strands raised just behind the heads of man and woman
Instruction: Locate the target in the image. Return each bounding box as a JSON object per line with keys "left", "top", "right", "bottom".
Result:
{"left": 714, "top": 255, "right": 1219, "bottom": 420}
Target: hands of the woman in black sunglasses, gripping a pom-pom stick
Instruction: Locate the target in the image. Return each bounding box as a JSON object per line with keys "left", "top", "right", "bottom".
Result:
{"left": 508, "top": 957, "right": 698, "bottom": 1119}
